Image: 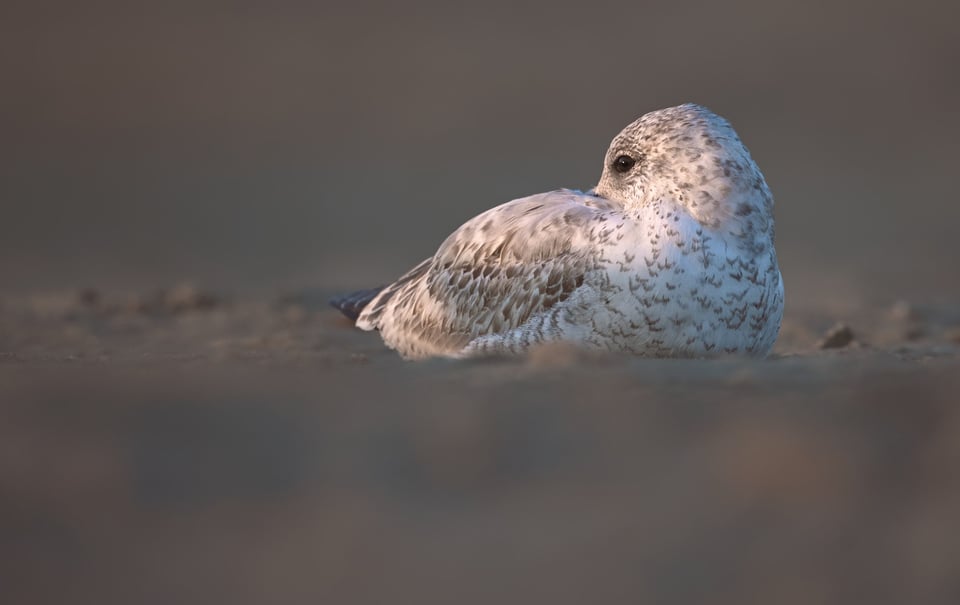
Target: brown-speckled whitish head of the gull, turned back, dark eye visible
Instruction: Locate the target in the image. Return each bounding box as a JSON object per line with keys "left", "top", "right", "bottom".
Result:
{"left": 595, "top": 104, "right": 773, "bottom": 231}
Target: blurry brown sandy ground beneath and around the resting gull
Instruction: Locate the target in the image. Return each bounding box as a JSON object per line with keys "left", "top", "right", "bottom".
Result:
{"left": 0, "top": 286, "right": 960, "bottom": 603}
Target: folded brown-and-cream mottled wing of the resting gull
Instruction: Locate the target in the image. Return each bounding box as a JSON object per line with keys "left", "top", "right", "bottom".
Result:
{"left": 357, "top": 189, "right": 616, "bottom": 358}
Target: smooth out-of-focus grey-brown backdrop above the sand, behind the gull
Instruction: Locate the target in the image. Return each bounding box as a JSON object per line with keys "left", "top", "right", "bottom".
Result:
{"left": 0, "top": 1, "right": 960, "bottom": 302}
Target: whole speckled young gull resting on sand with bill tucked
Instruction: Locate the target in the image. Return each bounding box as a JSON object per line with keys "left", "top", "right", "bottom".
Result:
{"left": 331, "top": 103, "right": 784, "bottom": 359}
